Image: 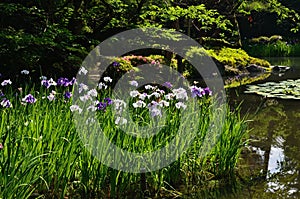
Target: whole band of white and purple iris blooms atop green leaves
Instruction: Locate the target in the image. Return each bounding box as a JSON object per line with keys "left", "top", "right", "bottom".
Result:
{"left": 0, "top": 68, "right": 212, "bottom": 129}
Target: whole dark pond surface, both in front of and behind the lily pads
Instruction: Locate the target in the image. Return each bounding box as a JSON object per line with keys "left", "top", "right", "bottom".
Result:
{"left": 224, "top": 57, "right": 300, "bottom": 198}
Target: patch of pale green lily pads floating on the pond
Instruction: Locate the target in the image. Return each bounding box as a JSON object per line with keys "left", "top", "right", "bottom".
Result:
{"left": 245, "top": 79, "right": 300, "bottom": 100}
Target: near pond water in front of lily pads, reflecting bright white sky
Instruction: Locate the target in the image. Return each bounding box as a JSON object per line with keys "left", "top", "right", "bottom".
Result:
{"left": 189, "top": 95, "right": 300, "bottom": 199}
